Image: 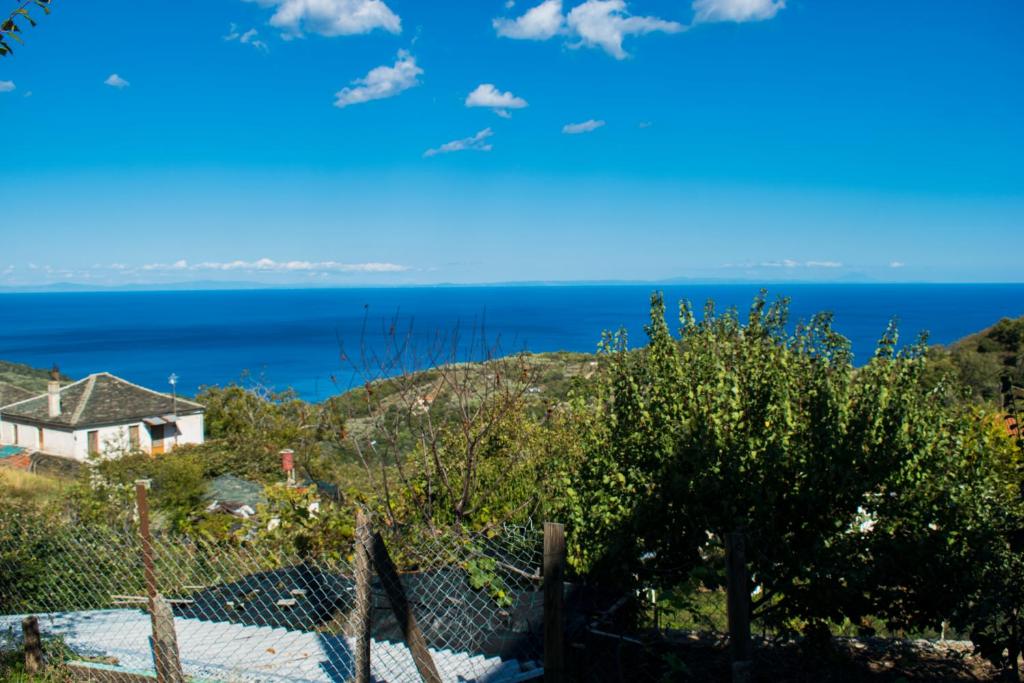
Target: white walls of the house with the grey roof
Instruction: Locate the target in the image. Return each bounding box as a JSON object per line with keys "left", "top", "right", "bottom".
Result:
{"left": 0, "top": 414, "right": 204, "bottom": 461}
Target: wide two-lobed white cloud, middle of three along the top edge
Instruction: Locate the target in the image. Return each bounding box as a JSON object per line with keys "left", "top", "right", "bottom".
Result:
{"left": 493, "top": 0, "right": 686, "bottom": 59}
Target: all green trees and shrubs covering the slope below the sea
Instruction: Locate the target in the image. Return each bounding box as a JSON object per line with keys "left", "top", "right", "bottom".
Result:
{"left": 0, "top": 295, "right": 1024, "bottom": 683}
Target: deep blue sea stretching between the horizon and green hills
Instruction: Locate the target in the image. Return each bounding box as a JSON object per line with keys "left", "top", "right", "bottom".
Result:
{"left": 0, "top": 285, "right": 1024, "bottom": 400}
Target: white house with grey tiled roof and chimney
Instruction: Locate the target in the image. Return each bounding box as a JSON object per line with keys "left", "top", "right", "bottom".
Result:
{"left": 0, "top": 373, "right": 205, "bottom": 460}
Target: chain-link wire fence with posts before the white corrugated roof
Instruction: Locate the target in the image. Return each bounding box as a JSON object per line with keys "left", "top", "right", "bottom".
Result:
{"left": 0, "top": 489, "right": 544, "bottom": 683}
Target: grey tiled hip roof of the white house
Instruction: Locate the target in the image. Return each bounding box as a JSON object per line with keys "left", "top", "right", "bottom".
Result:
{"left": 0, "top": 373, "right": 204, "bottom": 428}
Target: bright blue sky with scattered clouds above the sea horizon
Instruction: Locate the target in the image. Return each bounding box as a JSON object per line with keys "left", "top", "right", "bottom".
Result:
{"left": 0, "top": 0, "right": 1024, "bottom": 286}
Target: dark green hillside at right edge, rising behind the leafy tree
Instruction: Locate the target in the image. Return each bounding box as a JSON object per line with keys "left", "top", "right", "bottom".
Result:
{"left": 932, "top": 316, "right": 1024, "bottom": 400}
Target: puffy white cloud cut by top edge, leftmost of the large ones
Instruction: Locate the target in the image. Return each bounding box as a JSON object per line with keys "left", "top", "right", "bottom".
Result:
{"left": 244, "top": 0, "right": 401, "bottom": 37}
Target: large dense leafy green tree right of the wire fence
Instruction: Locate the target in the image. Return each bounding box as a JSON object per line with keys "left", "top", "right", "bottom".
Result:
{"left": 562, "top": 294, "right": 1021, "bottom": 679}
